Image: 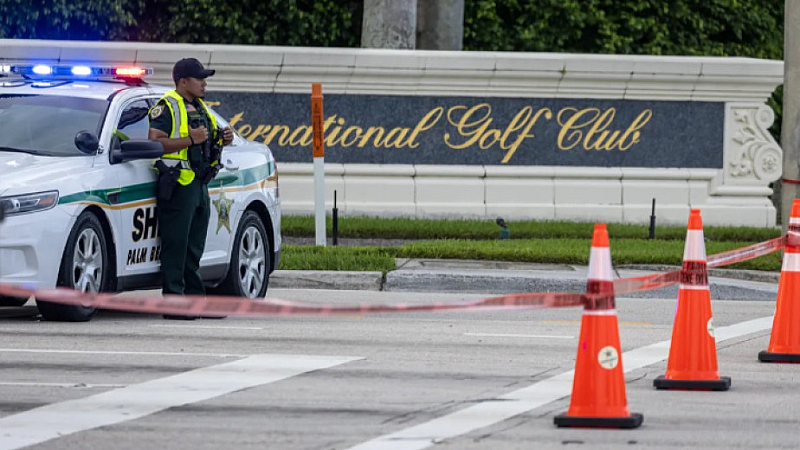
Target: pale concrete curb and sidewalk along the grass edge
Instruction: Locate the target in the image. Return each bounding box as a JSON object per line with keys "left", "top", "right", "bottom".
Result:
{"left": 270, "top": 259, "right": 780, "bottom": 301}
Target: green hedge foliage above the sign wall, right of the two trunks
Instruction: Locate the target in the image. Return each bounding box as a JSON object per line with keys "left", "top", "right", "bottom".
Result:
{"left": 464, "top": 0, "right": 784, "bottom": 59}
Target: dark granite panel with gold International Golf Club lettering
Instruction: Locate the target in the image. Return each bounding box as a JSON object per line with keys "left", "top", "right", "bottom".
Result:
{"left": 207, "top": 92, "right": 724, "bottom": 169}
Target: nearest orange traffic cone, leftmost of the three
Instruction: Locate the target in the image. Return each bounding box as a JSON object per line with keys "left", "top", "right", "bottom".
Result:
{"left": 554, "top": 224, "right": 643, "bottom": 428}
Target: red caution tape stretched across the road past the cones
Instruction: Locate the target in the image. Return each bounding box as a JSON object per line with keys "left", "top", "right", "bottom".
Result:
{"left": 0, "top": 236, "right": 787, "bottom": 317}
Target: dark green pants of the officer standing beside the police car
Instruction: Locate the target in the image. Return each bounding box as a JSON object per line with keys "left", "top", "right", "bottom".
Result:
{"left": 158, "top": 179, "right": 210, "bottom": 295}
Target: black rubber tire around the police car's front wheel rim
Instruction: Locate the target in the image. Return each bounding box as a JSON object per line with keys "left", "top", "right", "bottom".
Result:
{"left": 36, "top": 211, "right": 111, "bottom": 322}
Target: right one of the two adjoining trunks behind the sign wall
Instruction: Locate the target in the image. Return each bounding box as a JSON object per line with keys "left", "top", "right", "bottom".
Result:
{"left": 417, "top": 0, "right": 464, "bottom": 50}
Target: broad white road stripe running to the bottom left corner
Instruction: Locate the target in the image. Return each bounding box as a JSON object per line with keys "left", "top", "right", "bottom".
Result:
{"left": 0, "top": 355, "right": 362, "bottom": 450}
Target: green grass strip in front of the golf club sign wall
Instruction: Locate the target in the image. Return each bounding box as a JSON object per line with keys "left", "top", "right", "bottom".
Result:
{"left": 280, "top": 216, "right": 781, "bottom": 272}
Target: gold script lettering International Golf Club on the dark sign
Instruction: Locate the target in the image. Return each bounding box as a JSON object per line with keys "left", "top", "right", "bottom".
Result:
{"left": 214, "top": 98, "right": 653, "bottom": 164}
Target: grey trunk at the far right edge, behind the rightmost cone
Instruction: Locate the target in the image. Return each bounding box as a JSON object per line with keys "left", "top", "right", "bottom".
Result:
{"left": 780, "top": 0, "right": 800, "bottom": 233}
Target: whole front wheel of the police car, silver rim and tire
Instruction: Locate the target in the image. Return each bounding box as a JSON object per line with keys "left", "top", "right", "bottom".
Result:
{"left": 36, "top": 211, "right": 111, "bottom": 322}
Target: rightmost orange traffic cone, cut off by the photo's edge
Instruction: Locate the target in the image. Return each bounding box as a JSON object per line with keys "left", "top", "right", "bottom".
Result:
{"left": 758, "top": 199, "right": 800, "bottom": 363}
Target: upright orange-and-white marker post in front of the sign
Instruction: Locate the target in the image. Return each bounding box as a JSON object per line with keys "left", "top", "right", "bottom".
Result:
{"left": 311, "top": 83, "right": 327, "bottom": 247}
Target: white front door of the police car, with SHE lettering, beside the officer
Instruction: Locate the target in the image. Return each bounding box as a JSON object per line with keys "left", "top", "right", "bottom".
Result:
{"left": 111, "top": 98, "right": 161, "bottom": 285}
